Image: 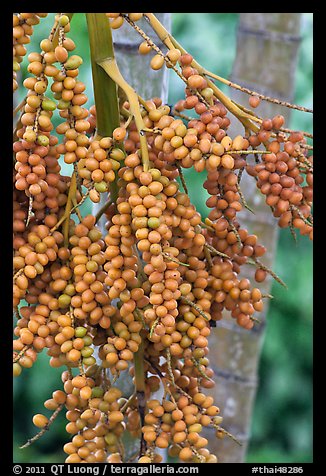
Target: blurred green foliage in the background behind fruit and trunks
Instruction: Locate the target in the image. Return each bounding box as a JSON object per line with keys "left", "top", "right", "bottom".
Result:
{"left": 13, "top": 13, "right": 312, "bottom": 463}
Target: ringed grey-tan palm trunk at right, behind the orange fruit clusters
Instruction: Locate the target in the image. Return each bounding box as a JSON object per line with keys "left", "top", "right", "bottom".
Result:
{"left": 206, "top": 13, "right": 301, "bottom": 463}
